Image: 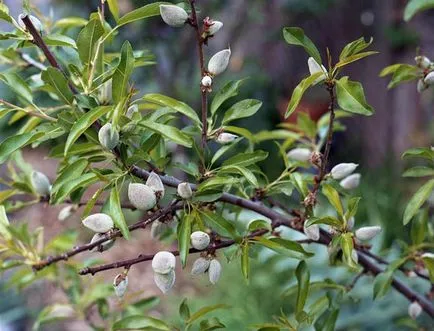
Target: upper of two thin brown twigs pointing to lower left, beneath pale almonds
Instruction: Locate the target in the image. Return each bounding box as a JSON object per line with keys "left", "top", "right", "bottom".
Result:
{"left": 32, "top": 200, "right": 183, "bottom": 271}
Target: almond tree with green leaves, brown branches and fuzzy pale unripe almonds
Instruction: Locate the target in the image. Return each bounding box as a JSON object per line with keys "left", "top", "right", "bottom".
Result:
{"left": 0, "top": 0, "right": 434, "bottom": 330}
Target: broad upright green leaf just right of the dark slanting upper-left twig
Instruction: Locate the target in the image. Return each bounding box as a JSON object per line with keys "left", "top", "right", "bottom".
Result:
{"left": 77, "top": 19, "right": 104, "bottom": 64}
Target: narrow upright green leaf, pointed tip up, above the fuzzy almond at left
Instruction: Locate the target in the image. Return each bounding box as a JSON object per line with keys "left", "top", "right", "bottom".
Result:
{"left": 112, "top": 40, "right": 134, "bottom": 103}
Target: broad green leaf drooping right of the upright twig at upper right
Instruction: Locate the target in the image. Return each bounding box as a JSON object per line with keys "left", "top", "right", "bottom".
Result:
{"left": 336, "top": 77, "right": 374, "bottom": 116}
